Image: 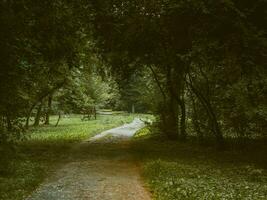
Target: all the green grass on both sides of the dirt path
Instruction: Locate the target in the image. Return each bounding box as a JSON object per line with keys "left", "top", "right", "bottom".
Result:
{"left": 0, "top": 115, "right": 267, "bottom": 200}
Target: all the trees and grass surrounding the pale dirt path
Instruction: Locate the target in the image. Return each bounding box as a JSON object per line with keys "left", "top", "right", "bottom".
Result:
{"left": 0, "top": 0, "right": 267, "bottom": 200}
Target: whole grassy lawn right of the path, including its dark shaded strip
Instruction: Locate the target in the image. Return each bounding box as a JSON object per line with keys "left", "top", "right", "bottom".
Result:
{"left": 132, "top": 128, "right": 267, "bottom": 200}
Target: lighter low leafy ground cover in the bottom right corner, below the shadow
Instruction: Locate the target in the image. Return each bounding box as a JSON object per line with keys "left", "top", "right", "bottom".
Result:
{"left": 145, "top": 161, "right": 267, "bottom": 200}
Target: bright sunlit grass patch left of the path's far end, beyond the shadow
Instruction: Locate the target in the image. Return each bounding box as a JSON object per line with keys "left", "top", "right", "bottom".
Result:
{"left": 28, "top": 115, "right": 133, "bottom": 143}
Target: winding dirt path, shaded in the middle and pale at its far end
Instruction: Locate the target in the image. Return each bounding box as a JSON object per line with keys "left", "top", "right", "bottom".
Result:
{"left": 28, "top": 119, "right": 153, "bottom": 200}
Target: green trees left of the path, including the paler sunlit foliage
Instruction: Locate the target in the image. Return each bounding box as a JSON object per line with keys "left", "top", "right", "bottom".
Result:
{"left": 0, "top": 0, "right": 119, "bottom": 143}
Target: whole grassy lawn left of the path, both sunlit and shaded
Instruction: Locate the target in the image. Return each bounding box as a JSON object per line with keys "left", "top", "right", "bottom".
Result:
{"left": 0, "top": 115, "right": 136, "bottom": 200}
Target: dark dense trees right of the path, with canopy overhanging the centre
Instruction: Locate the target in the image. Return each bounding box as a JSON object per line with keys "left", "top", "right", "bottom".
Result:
{"left": 89, "top": 0, "right": 267, "bottom": 146}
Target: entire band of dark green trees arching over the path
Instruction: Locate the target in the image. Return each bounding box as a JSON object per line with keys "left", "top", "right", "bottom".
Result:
{"left": 0, "top": 0, "right": 267, "bottom": 147}
